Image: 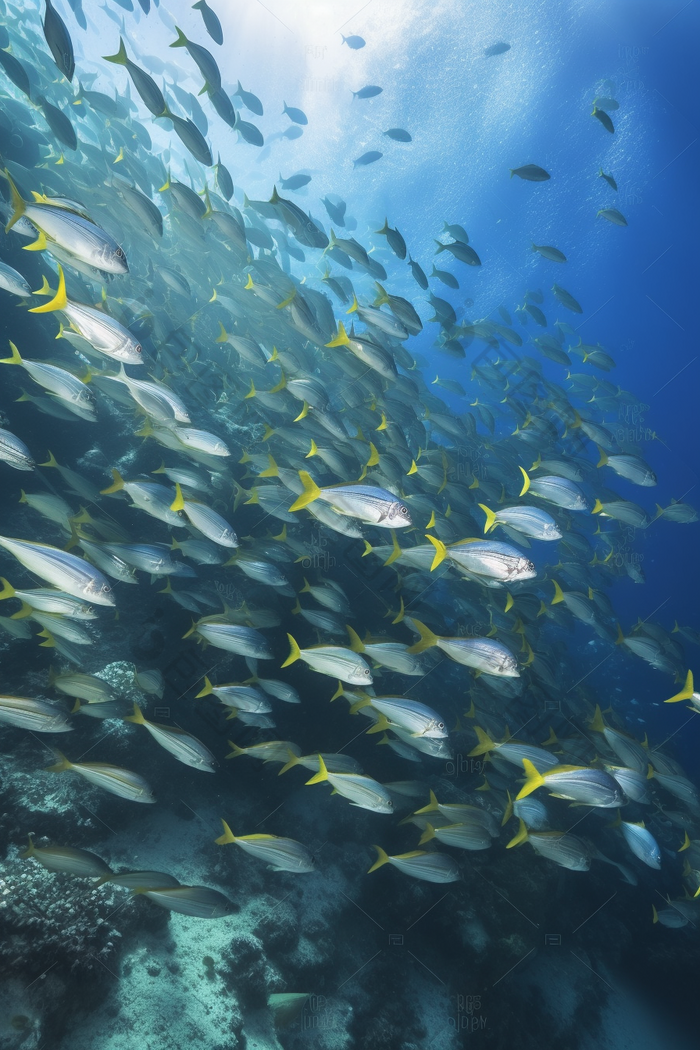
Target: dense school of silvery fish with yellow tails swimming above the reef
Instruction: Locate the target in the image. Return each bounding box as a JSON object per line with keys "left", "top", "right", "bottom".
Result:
{"left": 0, "top": 0, "right": 700, "bottom": 944}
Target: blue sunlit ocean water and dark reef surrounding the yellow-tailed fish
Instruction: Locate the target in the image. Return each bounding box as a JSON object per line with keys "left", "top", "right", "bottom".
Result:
{"left": 0, "top": 0, "right": 700, "bottom": 1050}
